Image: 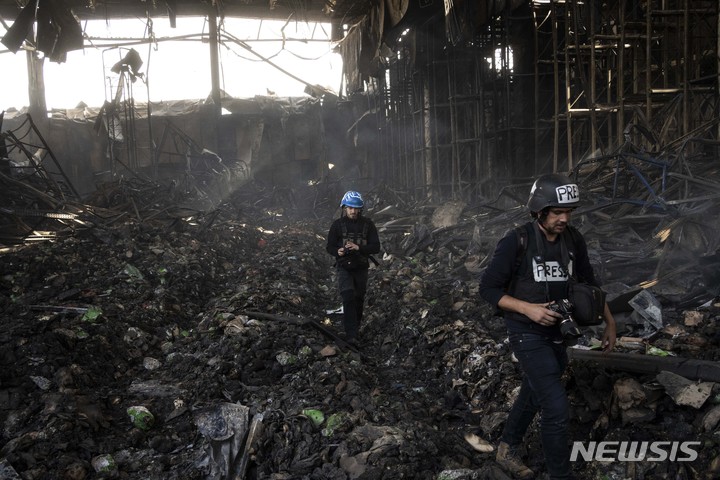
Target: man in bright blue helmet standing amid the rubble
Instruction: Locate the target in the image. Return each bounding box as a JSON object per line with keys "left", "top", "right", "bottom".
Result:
{"left": 326, "top": 190, "right": 380, "bottom": 345}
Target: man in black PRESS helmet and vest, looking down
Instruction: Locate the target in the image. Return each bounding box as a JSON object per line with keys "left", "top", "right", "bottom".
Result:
{"left": 480, "top": 174, "right": 616, "bottom": 479}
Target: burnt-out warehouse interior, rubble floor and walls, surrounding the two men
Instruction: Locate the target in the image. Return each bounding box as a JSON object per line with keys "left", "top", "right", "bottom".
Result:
{"left": 0, "top": 0, "right": 720, "bottom": 480}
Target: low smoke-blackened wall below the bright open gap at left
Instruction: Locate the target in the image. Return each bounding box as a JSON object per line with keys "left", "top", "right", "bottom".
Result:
{"left": 2, "top": 97, "right": 327, "bottom": 196}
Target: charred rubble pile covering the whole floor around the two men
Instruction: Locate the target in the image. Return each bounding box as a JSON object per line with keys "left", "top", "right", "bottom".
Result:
{"left": 0, "top": 151, "right": 720, "bottom": 480}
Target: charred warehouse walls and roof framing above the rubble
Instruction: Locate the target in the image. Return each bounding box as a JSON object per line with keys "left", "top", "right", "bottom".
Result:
{"left": 0, "top": 0, "right": 720, "bottom": 201}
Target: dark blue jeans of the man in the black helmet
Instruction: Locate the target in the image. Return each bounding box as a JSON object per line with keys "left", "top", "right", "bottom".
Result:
{"left": 502, "top": 333, "right": 573, "bottom": 479}
